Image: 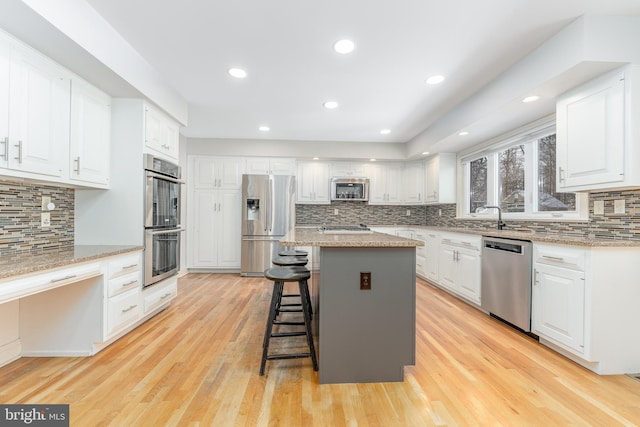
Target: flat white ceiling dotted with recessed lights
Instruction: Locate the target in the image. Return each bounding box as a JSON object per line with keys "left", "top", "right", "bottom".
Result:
{"left": 15, "top": 0, "right": 640, "bottom": 156}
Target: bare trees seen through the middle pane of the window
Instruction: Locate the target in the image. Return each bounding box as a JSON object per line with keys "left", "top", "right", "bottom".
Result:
{"left": 498, "top": 145, "right": 525, "bottom": 212}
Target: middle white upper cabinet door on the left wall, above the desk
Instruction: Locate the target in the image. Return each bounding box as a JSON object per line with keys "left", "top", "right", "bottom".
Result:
{"left": 7, "top": 43, "right": 71, "bottom": 177}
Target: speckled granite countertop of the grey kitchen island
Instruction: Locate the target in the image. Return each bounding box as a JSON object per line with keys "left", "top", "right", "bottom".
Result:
{"left": 280, "top": 228, "right": 424, "bottom": 248}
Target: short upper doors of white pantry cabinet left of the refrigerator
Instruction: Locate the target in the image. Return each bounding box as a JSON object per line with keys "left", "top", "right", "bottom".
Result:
{"left": 187, "top": 156, "right": 246, "bottom": 190}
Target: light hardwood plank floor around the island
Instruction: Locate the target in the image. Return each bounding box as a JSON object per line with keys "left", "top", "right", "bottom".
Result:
{"left": 0, "top": 274, "right": 640, "bottom": 427}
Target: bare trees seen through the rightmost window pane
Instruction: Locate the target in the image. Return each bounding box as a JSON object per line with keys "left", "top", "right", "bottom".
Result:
{"left": 538, "top": 134, "right": 576, "bottom": 212}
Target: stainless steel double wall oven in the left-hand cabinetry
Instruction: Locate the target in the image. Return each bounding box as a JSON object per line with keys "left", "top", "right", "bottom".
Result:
{"left": 144, "top": 155, "right": 184, "bottom": 287}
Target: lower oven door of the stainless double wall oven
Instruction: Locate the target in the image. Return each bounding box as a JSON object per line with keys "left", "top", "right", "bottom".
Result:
{"left": 144, "top": 228, "right": 184, "bottom": 286}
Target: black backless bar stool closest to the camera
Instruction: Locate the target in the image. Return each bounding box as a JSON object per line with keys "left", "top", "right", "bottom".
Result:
{"left": 260, "top": 267, "right": 318, "bottom": 375}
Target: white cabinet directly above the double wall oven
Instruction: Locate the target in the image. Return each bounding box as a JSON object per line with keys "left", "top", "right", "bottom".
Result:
{"left": 144, "top": 103, "right": 180, "bottom": 161}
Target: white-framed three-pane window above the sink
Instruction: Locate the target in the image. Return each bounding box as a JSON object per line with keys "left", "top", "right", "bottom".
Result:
{"left": 459, "top": 125, "right": 587, "bottom": 220}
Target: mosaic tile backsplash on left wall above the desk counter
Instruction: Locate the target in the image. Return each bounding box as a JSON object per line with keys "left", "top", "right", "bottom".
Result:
{"left": 0, "top": 181, "right": 75, "bottom": 254}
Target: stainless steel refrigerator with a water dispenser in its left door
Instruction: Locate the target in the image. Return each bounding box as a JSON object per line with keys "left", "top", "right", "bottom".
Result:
{"left": 240, "top": 175, "right": 296, "bottom": 276}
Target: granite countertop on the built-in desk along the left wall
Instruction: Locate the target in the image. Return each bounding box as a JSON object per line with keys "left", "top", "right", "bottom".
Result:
{"left": 0, "top": 245, "right": 144, "bottom": 279}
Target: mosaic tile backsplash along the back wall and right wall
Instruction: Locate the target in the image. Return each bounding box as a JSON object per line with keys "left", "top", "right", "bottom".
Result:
{"left": 296, "top": 189, "right": 640, "bottom": 240}
